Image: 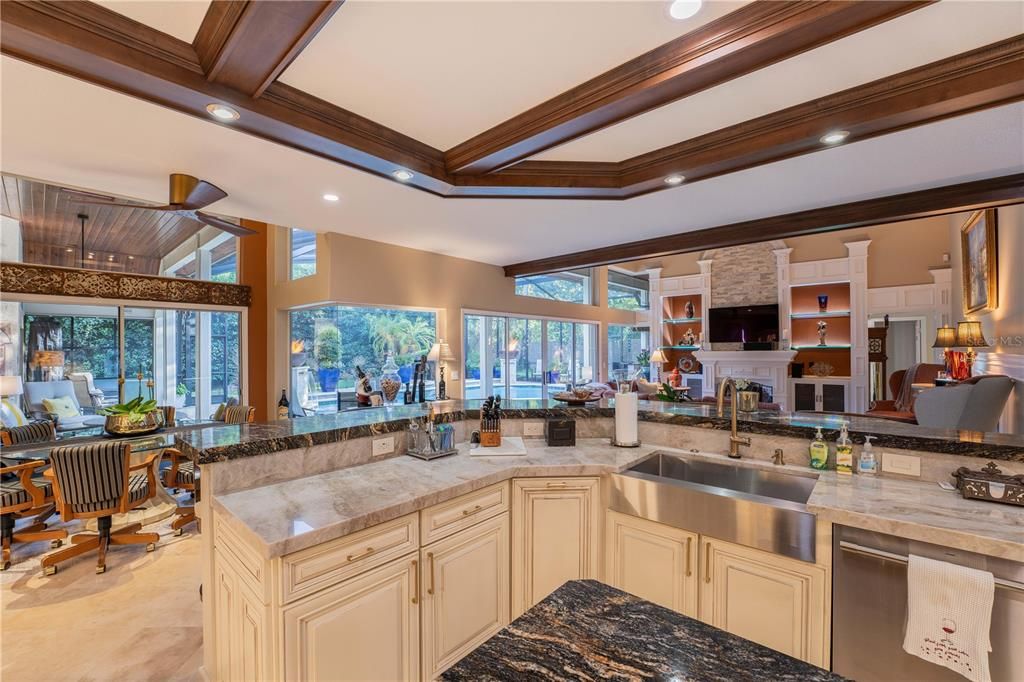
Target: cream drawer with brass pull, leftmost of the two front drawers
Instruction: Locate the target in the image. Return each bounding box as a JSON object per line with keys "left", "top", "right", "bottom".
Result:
{"left": 281, "top": 514, "right": 420, "bottom": 604}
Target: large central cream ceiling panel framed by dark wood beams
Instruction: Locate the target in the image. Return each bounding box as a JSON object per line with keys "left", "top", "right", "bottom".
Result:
{"left": 281, "top": 0, "right": 745, "bottom": 150}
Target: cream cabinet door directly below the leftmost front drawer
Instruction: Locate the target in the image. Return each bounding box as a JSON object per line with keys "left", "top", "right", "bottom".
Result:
{"left": 283, "top": 554, "right": 420, "bottom": 681}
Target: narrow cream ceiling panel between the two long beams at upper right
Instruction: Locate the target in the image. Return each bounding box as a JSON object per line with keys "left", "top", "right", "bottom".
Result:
{"left": 534, "top": 0, "right": 1024, "bottom": 161}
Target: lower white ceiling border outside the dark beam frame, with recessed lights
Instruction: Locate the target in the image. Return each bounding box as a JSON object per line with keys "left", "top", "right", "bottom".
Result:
{"left": 0, "top": 57, "right": 1024, "bottom": 264}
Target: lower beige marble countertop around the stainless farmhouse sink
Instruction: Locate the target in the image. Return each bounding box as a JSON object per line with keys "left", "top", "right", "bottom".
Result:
{"left": 212, "top": 438, "right": 1024, "bottom": 561}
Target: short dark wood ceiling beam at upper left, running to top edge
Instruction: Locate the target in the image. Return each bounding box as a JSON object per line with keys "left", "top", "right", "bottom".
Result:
{"left": 193, "top": 0, "right": 344, "bottom": 97}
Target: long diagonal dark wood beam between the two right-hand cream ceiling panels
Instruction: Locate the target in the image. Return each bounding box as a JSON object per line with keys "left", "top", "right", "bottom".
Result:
{"left": 444, "top": 0, "right": 930, "bottom": 174}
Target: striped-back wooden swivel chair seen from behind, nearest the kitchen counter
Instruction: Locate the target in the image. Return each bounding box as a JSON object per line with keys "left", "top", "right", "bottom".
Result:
{"left": 42, "top": 442, "right": 160, "bottom": 576}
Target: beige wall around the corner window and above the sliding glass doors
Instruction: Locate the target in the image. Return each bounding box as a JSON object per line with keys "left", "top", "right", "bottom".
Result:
{"left": 267, "top": 227, "right": 637, "bottom": 411}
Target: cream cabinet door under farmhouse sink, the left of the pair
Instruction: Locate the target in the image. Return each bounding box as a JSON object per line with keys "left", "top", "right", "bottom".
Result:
{"left": 604, "top": 510, "right": 699, "bottom": 617}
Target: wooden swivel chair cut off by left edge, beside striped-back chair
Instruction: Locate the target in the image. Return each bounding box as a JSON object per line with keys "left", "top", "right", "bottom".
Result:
{"left": 0, "top": 456, "right": 68, "bottom": 570}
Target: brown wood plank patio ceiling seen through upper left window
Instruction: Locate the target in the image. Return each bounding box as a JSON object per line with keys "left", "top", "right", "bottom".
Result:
{"left": 0, "top": 174, "right": 203, "bottom": 274}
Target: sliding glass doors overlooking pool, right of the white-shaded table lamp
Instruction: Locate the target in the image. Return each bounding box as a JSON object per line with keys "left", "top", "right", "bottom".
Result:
{"left": 463, "top": 314, "right": 597, "bottom": 399}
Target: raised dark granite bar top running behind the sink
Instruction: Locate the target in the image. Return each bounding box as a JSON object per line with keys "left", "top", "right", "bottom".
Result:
{"left": 176, "top": 399, "right": 1024, "bottom": 464}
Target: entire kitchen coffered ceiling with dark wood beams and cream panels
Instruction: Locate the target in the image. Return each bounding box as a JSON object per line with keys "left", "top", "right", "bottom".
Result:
{"left": 0, "top": 0, "right": 1024, "bottom": 265}
